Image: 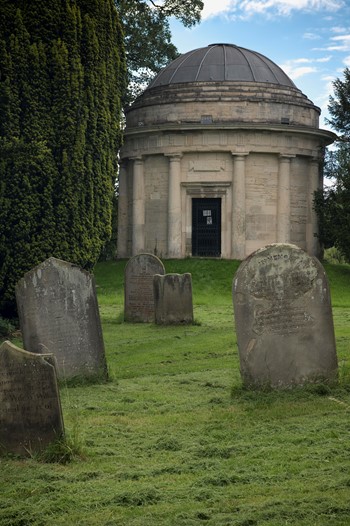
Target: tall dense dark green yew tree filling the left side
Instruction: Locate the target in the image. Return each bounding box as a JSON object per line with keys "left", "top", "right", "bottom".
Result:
{"left": 0, "top": 0, "right": 125, "bottom": 317}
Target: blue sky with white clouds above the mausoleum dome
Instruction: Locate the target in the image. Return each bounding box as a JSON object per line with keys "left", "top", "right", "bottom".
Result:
{"left": 171, "top": 0, "right": 350, "bottom": 129}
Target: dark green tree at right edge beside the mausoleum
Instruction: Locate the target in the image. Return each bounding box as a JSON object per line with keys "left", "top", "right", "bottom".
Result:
{"left": 315, "top": 68, "right": 350, "bottom": 262}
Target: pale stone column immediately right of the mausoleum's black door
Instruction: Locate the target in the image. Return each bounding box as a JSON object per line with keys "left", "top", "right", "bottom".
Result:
{"left": 232, "top": 152, "right": 248, "bottom": 259}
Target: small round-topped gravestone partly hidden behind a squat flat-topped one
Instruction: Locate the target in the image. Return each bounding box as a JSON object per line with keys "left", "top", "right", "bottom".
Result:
{"left": 124, "top": 254, "right": 165, "bottom": 323}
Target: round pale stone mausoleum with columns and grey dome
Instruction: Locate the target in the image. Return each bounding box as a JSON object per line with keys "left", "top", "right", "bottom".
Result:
{"left": 118, "top": 44, "right": 335, "bottom": 259}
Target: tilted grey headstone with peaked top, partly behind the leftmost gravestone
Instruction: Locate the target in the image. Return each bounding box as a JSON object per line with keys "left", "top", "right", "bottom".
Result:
{"left": 16, "top": 257, "right": 107, "bottom": 379}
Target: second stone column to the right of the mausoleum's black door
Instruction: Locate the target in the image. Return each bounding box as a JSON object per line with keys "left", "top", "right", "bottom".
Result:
{"left": 276, "top": 155, "right": 294, "bottom": 243}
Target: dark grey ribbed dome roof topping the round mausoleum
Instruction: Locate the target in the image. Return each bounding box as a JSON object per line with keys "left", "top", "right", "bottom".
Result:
{"left": 148, "top": 44, "right": 296, "bottom": 89}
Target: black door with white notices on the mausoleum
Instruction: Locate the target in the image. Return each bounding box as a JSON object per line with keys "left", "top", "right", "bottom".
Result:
{"left": 192, "top": 198, "right": 221, "bottom": 257}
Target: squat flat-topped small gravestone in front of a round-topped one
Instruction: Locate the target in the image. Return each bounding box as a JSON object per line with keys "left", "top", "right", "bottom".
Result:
{"left": 153, "top": 273, "right": 193, "bottom": 325}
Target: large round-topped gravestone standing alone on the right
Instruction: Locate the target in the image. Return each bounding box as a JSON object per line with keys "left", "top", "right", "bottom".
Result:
{"left": 233, "top": 243, "right": 338, "bottom": 387}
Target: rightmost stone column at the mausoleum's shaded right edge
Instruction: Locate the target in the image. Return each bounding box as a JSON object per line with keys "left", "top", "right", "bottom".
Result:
{"left": 306, "top": 157, "right": 320, "bottom": 257}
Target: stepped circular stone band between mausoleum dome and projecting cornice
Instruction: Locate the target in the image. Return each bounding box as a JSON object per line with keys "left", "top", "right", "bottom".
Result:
{"left": 127, "top": 82, "right": 320, "bottom": 128}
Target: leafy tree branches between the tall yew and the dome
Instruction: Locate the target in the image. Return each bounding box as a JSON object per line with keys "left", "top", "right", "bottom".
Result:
{"left": 115, "top": 0, "right": 203, "bottom": 104}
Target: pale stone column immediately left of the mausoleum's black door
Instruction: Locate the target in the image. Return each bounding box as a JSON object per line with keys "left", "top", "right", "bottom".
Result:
{"left": 167, "top": 154, "right": 182, "bottom": 258}
